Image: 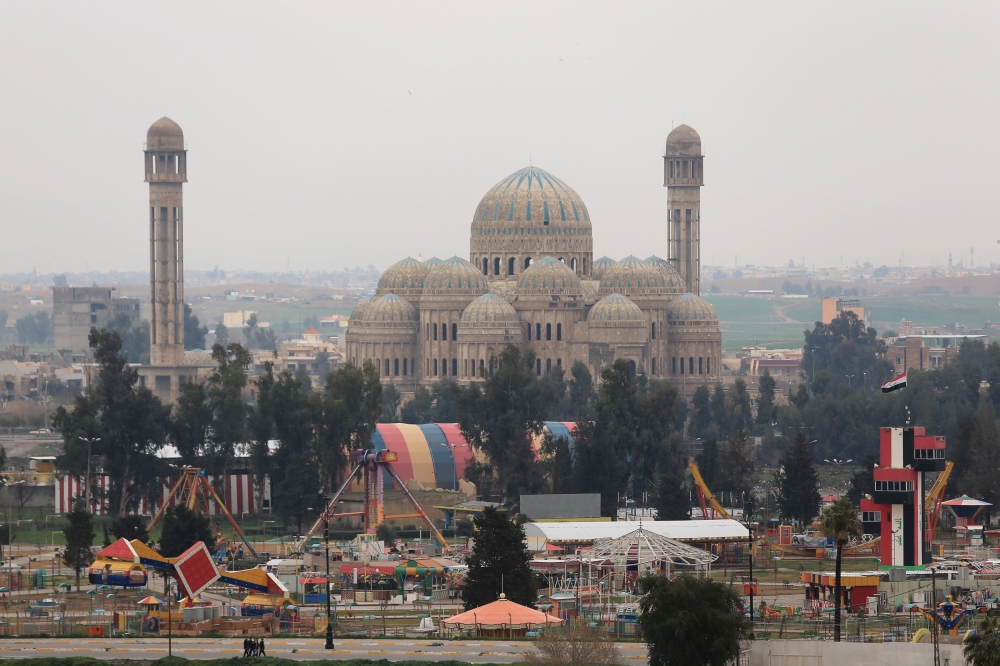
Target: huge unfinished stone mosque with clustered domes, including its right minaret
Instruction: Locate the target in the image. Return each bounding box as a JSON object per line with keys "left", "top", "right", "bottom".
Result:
{"left": 345, "top": 125, "right": 722, "bottom": 396}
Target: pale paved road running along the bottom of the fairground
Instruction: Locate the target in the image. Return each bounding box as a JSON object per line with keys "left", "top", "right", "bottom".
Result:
{"left": 0, "top": 638, "right": 647, "bottom": 664}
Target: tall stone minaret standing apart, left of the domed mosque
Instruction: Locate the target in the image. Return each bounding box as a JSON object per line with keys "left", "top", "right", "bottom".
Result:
{"left": 145, "top": 117, "right": 187, "bottom": 366}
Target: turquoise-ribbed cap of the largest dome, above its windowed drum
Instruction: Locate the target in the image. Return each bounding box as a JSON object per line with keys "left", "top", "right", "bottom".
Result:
{"left": 472, "top": 166, "right": 590, "bottom": 229}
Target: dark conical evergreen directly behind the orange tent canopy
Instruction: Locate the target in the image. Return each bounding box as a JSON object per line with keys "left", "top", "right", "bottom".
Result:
{"left": 462, "top": 507, "right": 538, "bottom": 610}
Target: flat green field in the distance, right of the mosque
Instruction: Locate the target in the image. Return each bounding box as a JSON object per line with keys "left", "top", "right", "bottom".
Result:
{"left": 705, "top": 294, "right": 1000, "bottom": 349}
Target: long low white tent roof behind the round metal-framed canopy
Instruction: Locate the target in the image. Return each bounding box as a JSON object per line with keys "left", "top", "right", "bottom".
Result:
{"left": 524, "top": 520, "right": 750, "bottom": 543}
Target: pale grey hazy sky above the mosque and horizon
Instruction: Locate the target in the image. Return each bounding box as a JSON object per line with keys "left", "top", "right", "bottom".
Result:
{"left": 0, "top": 0, "right": 1000, "bottom": 273}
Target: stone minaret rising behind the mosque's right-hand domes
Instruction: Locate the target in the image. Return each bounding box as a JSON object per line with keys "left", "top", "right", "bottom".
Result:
{"left": 663, "top": 125, "right": 705, "bottom": 296}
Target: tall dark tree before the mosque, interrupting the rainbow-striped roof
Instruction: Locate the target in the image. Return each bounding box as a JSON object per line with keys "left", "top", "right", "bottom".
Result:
{"left": 457, "top": 345, "right": 556, "bottom": 505}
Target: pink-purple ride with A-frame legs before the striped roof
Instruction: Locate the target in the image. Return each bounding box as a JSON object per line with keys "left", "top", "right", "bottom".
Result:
{"left": 295, "top": 449, "right": 452, "bottom": 553}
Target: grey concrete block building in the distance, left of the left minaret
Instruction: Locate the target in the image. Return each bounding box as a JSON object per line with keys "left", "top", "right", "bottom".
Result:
{"left": 52, "top": 287, "right": 139, "bottom": 352}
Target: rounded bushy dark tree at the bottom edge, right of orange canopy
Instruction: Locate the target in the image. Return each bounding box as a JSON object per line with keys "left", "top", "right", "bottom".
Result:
{"left": 639, "top": 574, "right": 750, "bottom": 666}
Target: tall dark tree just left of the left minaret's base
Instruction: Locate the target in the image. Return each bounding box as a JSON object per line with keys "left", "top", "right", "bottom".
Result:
{"left": 53, "top": 329, "right": 170, "bottom": 516}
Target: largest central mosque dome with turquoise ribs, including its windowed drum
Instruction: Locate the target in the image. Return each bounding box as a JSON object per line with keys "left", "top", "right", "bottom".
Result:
{"left": 470, "top": 166, "right": 594, "bottom": 280}
